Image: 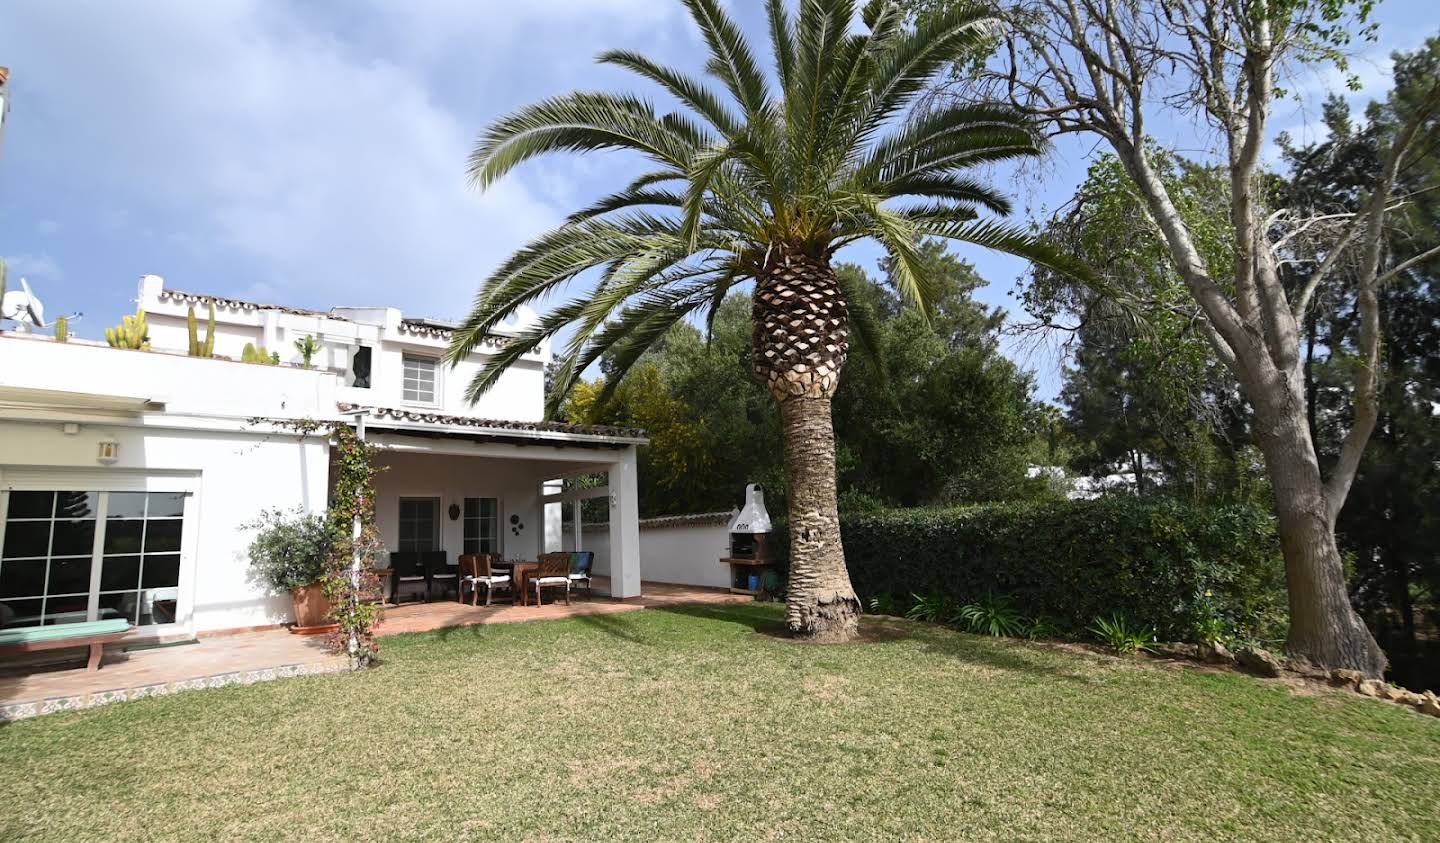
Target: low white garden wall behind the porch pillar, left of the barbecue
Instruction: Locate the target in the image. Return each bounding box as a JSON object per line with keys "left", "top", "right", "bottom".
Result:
{"left": 564, "top": 512, "right": 733, "bottom": 588}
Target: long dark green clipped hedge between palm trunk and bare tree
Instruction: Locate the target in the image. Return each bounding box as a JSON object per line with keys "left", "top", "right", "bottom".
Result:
{"left": 776, "top": 497, "right": 1286, "bottom": 640}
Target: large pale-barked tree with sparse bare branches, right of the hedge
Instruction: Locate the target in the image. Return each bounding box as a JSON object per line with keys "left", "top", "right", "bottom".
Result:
{"left": 982, "top": 0, "right": 1440, "bottom": 676}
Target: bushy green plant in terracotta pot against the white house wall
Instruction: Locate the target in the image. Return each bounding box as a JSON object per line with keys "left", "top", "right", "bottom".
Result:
{"left": 245, "top": 509, "right": 336, "bottom": 633}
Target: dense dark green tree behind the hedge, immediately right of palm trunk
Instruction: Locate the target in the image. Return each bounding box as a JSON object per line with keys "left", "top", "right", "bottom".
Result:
{"left": 835, "top": 241, "right": 1037, "bottom": 506}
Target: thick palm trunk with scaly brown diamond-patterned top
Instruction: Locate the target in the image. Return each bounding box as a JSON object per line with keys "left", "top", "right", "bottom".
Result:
{"left": 752, "top": 244, "right": 860, "bottom": 641}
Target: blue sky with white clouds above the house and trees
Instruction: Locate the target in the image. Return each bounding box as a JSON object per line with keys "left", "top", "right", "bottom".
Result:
{"left": 0, "top": 0, "right": 1440, "bottom": 398}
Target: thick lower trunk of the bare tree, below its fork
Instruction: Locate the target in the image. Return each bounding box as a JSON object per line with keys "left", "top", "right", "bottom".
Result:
{"left": 1254, "top": 391, "right": 1385, "bottom": 679}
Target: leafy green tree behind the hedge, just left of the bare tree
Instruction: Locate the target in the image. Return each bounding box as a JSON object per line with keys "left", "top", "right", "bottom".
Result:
{"left": 1022, "top": 150, "right": 1250, "bottom": 500}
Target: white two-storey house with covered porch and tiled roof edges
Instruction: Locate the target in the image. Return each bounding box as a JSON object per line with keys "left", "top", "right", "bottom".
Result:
{"left": 0, "top": 275, "right": 645, "bottom": 638}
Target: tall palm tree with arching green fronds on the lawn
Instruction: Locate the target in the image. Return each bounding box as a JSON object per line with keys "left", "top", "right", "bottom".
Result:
{"left": 449, "top": 0, "right": 1068, "bottom": 640}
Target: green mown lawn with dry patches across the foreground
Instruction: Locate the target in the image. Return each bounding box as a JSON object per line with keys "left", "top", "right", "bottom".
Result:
{"left": 0, "top": 604, "right": 1440, "bottom": 842}
